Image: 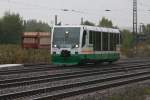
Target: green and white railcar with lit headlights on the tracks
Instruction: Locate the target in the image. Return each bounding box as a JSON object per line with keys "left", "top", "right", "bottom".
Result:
{"left": 51, "top": 25, "right": 120, "bottom": 64}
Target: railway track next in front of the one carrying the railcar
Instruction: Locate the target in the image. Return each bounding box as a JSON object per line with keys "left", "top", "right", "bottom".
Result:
{"left": 0, "top": 63, "right": 150, "bottom": 89}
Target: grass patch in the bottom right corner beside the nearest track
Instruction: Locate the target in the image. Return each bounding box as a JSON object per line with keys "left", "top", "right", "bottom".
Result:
{"left": 73, "top": 86, "right": 150, "bottom": 100}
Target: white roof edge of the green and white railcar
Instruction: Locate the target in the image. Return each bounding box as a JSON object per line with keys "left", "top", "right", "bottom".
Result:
{"left": 54, "top": 25, "right": 120, "bottom": 33}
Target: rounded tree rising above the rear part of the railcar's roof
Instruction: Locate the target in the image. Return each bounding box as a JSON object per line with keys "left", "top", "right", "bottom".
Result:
{"left": 98, "top": 17, "right": 113, "bottom": 28}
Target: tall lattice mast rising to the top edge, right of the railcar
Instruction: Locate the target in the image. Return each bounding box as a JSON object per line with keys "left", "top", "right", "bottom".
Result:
{"left": 133, "top": 0, "right": 137, "bottom": 54}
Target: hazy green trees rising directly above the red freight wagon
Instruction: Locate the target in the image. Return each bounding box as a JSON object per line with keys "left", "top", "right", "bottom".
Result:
{"left": 24, "top": 20, "right": 50, "bottom": 32}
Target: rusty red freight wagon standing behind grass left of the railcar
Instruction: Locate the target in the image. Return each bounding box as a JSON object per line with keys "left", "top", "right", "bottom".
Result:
{"left": 22, "top": 32, "right": 50, "bottom": 49}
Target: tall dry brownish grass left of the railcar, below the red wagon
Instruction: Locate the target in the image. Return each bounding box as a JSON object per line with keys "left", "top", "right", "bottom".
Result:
{"left": 0, "top": 45, "right": 50, "bottom": 64}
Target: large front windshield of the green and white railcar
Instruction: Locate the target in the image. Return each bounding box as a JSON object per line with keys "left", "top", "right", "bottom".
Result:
{"left": 53, "top": 27, "right": 80, "bottom": 48}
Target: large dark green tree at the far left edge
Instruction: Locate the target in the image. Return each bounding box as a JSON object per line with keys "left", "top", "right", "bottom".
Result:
{"left": 0, "top": 12, "right": 23, "bottom": 44}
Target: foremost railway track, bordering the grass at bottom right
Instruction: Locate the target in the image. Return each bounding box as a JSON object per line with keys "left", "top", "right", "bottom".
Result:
{"left": 33, "top": 70, "right": 150, "bottom": 100}
